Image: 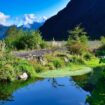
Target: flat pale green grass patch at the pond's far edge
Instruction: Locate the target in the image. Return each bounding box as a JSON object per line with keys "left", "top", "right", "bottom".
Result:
{"left": 38, "top": 66, "right": 92, "bottom": 78}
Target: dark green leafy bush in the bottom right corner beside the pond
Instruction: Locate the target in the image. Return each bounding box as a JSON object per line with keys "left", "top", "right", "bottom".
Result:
{"left": 87, "top": 78, "right": 105, "bottom": 105}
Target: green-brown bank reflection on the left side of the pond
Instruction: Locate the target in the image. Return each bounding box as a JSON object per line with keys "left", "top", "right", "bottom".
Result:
{"left": 0, "top": 79, "right": 40, "bottom": 103}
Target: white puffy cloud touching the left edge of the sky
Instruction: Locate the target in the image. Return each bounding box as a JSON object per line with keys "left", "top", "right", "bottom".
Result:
{"left": 0, "top": 12, "right": 10, "bottom": 26}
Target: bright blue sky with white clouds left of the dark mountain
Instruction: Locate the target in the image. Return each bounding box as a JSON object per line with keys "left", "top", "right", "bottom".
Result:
{"left": 0, "top": 0, "right": 70, "bottom": 26}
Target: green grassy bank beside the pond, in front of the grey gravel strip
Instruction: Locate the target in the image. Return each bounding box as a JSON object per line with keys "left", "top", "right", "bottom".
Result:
{"left": 0, "top": 52, "right": 94, "bottom": 81}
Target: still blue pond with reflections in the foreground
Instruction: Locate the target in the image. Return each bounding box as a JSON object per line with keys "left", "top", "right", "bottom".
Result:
{"left": 0, "top": 75, "right": 102, "bottom": 105}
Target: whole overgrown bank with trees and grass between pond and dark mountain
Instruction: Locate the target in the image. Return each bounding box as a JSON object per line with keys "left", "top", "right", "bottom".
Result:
{"left": 0, "top": 26, "right": 105, "bottom": 81}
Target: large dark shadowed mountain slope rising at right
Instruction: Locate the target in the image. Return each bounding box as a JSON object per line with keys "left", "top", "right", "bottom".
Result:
{"left": 40, "top": 0, "right": 105, "bottom": 40}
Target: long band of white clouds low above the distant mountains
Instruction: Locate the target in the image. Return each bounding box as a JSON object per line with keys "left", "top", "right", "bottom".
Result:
{"left": 0, "top": 12, "right": 47, "bottom": 27}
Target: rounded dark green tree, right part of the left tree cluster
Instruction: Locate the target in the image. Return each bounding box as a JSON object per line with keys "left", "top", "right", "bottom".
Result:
{"left": 15, "top": 31, "right": 45, "bottom": 49}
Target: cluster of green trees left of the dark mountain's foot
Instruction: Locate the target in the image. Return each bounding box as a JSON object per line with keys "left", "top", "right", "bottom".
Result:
{"left": 5, "top": 26, "right": 47, "bottom": 50}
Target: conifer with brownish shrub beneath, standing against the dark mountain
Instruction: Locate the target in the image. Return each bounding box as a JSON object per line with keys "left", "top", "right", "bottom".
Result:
{"left": 67, "top": 26, "right": 88, "bottom": 55}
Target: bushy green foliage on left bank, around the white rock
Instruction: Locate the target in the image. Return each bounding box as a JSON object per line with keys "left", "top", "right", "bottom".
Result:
{"left": 0, "top": 53, "right": 36, "bottom": 81}
